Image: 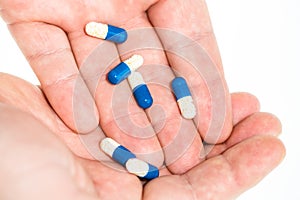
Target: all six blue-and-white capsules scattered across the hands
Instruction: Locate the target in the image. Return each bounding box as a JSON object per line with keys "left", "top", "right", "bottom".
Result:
{"left": 85, "top": 22, "right": 196, "bottom": 180}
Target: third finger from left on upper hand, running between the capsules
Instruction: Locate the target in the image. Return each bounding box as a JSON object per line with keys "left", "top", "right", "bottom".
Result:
{"left": 118, "top": 14, "right": 202, "bottom": 173}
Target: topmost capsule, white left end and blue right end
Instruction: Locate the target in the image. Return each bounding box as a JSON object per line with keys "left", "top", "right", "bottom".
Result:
{"left": 85, "top": 22, "right": 127, "bottom": 43}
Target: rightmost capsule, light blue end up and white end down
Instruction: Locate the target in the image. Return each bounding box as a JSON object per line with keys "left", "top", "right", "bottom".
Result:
{"left": 172, "top": 77, "right": 196, "bottom": 119}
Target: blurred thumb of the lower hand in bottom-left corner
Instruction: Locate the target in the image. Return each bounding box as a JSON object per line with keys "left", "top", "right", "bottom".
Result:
{"left": 0, "top": 103, "right": 97, "bottom": 200}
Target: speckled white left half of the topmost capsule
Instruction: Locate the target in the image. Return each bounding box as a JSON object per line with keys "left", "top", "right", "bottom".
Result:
{"left": 85, "top": 22, "right": 108, "bottom": 40}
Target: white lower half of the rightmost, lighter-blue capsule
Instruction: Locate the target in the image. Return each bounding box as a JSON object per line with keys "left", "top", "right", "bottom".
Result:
{"left": 177, "top": 96, "right": 197, "bottom": 119}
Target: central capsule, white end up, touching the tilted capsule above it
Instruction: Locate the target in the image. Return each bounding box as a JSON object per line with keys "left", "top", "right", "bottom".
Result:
{"left": 128, "top": 72, "right": 153, "bottom": 109}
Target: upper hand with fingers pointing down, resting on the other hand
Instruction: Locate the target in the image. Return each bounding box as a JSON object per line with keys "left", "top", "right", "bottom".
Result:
{"left": 0, "top": 0, "right": 233, "bottom": 174}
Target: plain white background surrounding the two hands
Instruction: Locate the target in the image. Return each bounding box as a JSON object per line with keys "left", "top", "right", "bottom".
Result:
{"left": 0, "top": 0, "right": 300, "bottom": 200}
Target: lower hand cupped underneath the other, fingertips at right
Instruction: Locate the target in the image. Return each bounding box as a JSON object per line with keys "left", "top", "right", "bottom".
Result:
{"left": 0, "top": 74, "right": 285, "bottom": 200}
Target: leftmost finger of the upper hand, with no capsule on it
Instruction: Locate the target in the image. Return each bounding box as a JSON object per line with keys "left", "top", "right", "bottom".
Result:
{"left": 9, "top": 22, "right": 99, "bottom": 133}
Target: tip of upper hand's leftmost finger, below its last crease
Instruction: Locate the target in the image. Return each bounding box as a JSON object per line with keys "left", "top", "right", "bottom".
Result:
{"left": 42, "top": 75, "right": 99, "bottom": 134}
